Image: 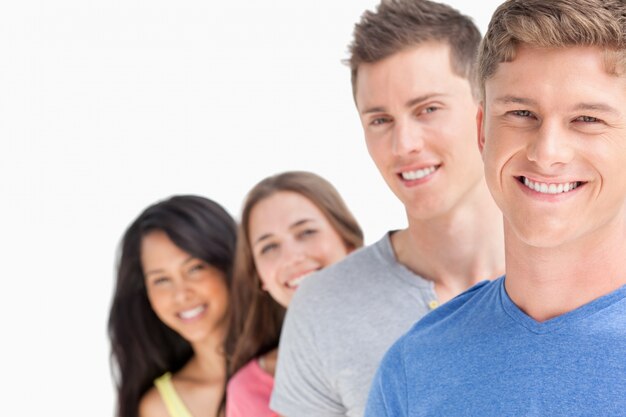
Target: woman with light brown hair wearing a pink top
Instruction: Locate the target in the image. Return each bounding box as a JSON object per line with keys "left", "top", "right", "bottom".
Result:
{"left": 226, "top": 172, "right": 363, "bottom": 417}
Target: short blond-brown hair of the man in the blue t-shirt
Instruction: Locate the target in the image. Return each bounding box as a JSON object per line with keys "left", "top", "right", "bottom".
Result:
{"left": 478, "top": 0, "right": 626, "bottom": 98}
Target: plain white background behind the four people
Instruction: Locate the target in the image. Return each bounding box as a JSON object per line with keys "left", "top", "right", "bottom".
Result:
{"left": 0, "top": 0, "right": 500, "bottom": 416}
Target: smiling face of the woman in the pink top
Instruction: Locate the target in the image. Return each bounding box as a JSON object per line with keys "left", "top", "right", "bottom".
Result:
{"left": 249, "top": 191, "right": 348, "bottom": 307}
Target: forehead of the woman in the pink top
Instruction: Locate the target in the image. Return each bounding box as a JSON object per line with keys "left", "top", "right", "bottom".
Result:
{"left": 248, "top": 191, "right": 325, "bottom": 236}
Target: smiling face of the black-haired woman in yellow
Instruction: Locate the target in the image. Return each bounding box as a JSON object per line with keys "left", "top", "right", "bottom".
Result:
{"left": 141, "top": 231, "right": 228, "bottom": 344}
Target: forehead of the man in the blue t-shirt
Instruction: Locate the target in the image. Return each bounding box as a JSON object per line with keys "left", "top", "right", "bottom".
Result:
{"left": 485, "top": 46, "right": 626, "bottom": 107}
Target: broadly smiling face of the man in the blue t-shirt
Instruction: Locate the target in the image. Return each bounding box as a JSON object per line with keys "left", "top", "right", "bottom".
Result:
{"left": 478, "top": 46, "right": 626, "bottom": 247}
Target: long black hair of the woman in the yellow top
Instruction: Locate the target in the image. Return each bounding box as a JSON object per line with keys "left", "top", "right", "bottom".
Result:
{"left": 108, "top": 195, "right": 236, "bottom": 417}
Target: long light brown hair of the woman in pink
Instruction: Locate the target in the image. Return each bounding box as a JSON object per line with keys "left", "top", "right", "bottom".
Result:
{"left": 226, "top": 171, "right": 363, "bottom": 376}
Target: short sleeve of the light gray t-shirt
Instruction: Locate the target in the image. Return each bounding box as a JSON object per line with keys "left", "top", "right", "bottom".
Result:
{"left": 270, "top": 288, "right": 345, "bottom": 417}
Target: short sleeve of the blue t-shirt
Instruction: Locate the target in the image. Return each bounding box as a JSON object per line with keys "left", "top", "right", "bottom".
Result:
{"left": 365, "top": 339, "right": 409, "bottom": 417}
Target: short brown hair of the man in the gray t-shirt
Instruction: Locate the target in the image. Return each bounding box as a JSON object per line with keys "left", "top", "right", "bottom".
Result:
{"left": 346, "top": 0, "right": 480, "bottom": 98}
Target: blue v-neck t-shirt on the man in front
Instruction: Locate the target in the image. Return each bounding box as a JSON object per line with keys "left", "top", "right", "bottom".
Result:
{"left": 365, "top": 278, "right": 626, "bottom": 417}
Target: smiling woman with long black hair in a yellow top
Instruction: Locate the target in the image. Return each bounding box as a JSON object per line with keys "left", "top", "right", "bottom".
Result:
{"left": 108, "top": 196, "right": 236, "bottom": 417}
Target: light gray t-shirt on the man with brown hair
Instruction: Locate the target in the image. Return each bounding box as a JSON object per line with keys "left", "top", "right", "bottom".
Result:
{"left": 270, "top": 234, "right": 437, "bottom": 417}
